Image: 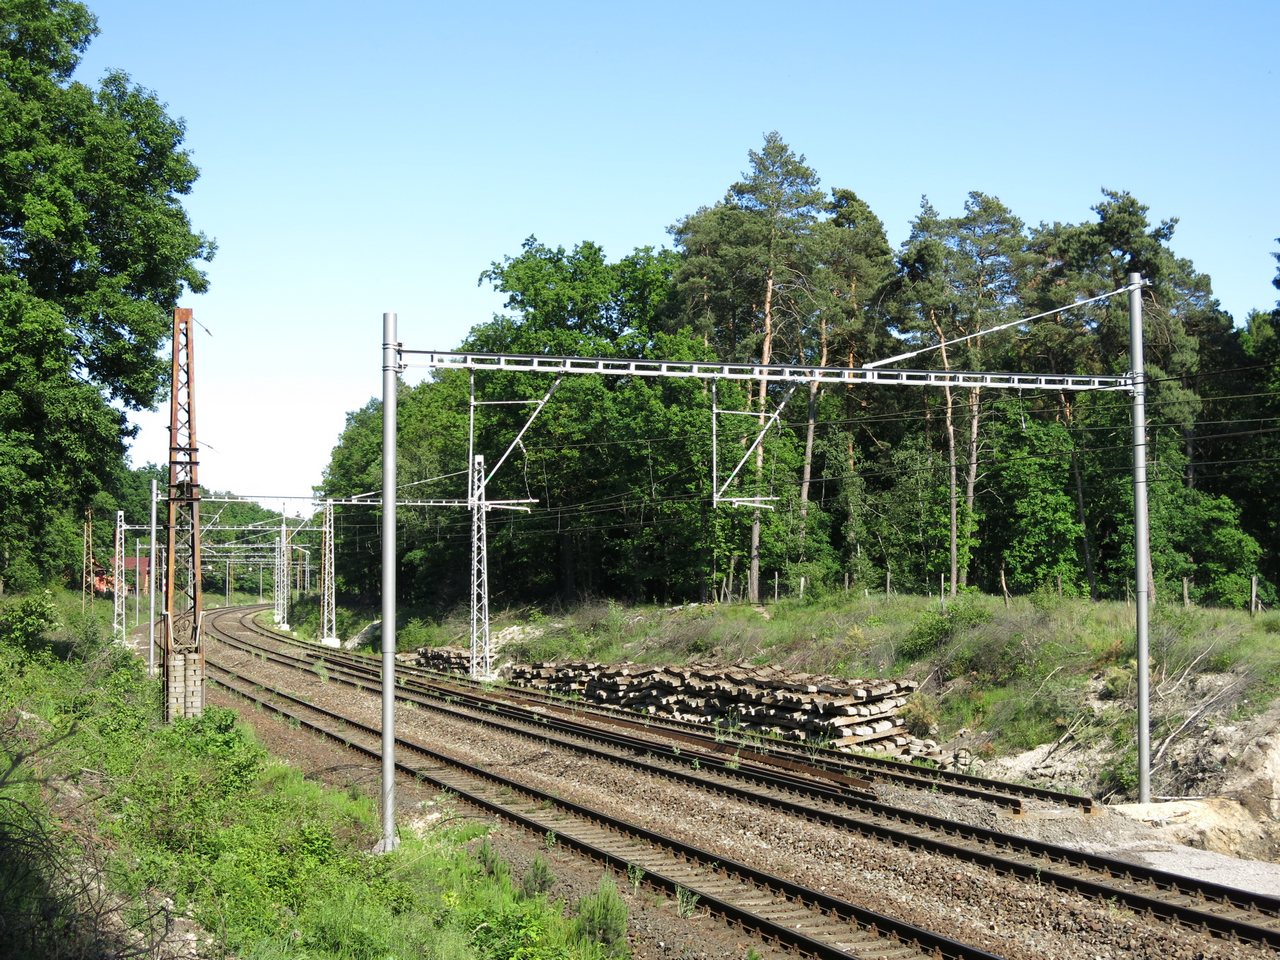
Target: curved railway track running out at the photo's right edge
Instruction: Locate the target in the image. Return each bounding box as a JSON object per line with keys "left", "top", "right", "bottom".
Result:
{"left": 210, "top": 609, "right": 1280, "bottom": 948}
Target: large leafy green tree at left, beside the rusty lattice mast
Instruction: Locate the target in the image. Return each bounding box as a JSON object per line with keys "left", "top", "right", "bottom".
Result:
{"left": 0, "top": 0, "right": 214, "bottom": 584}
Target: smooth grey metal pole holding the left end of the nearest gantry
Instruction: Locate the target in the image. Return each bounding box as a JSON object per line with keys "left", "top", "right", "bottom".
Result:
{"left": 378, "top": 314, "right": 399, "bottom": 852}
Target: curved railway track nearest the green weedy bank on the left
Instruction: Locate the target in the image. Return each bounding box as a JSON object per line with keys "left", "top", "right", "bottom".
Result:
{"left": 206, "top": 609, "right": 997, "bottom": 960}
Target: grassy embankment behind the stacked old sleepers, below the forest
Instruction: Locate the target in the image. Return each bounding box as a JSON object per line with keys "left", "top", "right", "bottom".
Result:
{"left": 386, "top": 593, "right": 1280, "bottom": 795}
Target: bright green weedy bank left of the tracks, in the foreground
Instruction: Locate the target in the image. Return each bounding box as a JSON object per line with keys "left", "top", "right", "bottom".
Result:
{"left": 0, "top": 594, "right": 626, "bottom": 960}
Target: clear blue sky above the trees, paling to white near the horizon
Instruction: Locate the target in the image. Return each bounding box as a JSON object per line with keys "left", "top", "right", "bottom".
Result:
{"left": 77, "top": 0, "right": 1280, "bottom": 502}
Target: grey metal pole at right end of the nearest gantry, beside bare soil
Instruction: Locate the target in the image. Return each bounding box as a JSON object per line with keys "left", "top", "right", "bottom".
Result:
{"left": 1129, "top": 274, "right": 1151, "bottom": 804}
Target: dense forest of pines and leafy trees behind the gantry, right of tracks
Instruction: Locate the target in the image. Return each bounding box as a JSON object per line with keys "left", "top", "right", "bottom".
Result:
{"left": 317, "top": 133, "right": 1280, "bottom": 607}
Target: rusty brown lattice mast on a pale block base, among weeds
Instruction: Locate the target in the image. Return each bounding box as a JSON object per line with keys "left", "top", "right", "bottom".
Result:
{"left": 161, "top": 308, "right": 205, "bottom": 721}
